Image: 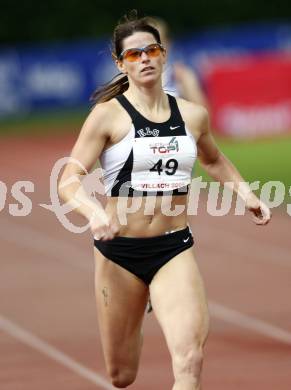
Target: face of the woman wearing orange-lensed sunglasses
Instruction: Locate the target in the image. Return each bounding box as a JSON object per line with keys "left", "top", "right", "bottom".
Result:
{"left": 117, "top": 32, "right": 166, "bottom": 86}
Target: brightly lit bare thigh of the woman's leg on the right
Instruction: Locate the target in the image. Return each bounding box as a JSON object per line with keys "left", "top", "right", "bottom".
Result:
{"left": 150, "top": 248, "right": 209, "bottom": 357}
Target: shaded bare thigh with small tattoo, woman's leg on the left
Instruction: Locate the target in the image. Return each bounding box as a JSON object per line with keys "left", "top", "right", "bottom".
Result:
{"left": 94, "top": 248, "right": 148, "bottom": 370}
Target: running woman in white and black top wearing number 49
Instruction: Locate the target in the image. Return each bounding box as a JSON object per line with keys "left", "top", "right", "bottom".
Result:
{"left": 59, "top": 12, "right": 270, "bottom": 390}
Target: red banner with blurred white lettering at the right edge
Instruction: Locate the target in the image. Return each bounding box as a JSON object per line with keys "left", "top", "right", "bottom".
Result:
{"left": 205, "top": 54, "right": 291, "bottom": 137}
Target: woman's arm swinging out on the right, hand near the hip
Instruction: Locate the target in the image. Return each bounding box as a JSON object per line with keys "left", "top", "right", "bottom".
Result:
{"left": 195, "top": 107, "right": 271, "bottom": 225}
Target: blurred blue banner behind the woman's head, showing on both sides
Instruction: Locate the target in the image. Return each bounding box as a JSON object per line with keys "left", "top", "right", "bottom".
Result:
{"left": 0, "top": 24, "right": 291, "bottom": 117}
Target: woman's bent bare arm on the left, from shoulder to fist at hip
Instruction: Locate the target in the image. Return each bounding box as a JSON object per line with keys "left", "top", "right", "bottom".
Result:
{"left": 58, "top": 102, "right": 118, "bottom": 240}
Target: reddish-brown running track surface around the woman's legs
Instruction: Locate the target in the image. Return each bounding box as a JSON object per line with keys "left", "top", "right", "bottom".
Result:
{"left": 0, "top": 136, "right": 291, "bottom": 390}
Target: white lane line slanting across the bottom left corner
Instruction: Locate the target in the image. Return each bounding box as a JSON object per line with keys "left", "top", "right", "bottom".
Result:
{"left": 0, "top": 315, "right": 114, "bottom": 390}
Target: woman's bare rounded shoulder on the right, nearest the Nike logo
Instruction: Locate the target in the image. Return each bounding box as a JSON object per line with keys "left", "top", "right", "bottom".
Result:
{"left": 177, "top": 98, "right": 209, "bottom": 140}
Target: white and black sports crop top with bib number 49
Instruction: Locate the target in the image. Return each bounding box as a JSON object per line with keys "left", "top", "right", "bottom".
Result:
{"left": 100, "top": 95, "right": 197, "bottom": 196}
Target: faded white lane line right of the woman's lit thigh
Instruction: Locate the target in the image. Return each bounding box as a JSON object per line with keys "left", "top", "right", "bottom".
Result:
{"left": 209, "top": 301, "right": 291, "bottom": 345}
